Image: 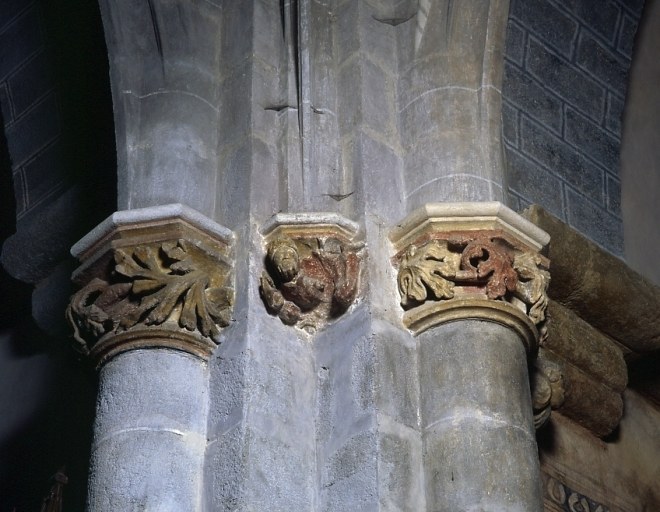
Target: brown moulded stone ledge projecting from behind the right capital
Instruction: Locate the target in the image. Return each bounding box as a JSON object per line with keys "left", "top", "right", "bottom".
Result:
{"left": 524, "top": 205, "right": 660, "bottom": 416}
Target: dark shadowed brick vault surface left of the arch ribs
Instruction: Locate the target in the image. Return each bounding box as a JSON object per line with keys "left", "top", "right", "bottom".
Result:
{"left": 0, "top": 0, "right": 116, "bottom": 283}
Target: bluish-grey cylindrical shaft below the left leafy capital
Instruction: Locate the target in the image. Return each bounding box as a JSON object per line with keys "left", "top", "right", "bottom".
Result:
{"left": 87, "top": 349, "right": 208, "bottom": 512}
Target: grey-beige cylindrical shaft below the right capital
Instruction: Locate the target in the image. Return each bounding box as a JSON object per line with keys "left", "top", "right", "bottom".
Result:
{"left": 419, "top": 319, "right": 542, "bottom": 512}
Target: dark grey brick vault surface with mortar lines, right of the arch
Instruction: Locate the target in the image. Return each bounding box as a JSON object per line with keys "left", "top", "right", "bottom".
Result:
{"left": 502, "top": 0, "right": 643, "bottom": 256}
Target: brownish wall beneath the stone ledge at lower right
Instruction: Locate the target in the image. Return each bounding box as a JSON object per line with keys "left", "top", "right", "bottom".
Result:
{"left": 539, "top": 390, "right": 660, "bottom": 512}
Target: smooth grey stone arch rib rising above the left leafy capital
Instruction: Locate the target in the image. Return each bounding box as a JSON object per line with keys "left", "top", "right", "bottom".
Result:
{"left": 101, "top": 0, "right": 224, "bottom": 217}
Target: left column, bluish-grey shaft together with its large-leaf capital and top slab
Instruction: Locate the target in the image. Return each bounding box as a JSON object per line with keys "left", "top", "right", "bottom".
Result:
{"left": 67, "top": 205, "right": 233, "bottom": 512}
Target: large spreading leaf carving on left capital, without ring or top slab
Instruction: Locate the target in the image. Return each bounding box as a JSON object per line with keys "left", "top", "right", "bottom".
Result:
{"left": 67, "top": 239, "right": 233, "bottom": 352}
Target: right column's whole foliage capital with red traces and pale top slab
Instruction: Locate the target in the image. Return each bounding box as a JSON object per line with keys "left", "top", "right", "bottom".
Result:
{"left": 390, "top": 202, "right": 550, "bottom": 358}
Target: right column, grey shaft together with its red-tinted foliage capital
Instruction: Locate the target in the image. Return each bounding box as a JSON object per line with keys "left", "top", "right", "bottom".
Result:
{"left": 391, "top": 202, "right": 549, "bottom": 512}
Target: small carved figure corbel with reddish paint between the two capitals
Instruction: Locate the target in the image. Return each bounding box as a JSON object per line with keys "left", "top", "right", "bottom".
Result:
{"left": 260, "top": 213, "right": 364, "bottom": 332}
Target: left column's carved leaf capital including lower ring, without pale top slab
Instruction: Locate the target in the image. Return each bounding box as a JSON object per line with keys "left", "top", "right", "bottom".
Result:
{"left": 66, "top": 216, "right": 234, "bottom": 361}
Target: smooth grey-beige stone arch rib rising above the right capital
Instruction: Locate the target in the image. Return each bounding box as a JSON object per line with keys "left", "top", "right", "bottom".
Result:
{"left": 398, "top": 0, "right": 508, "bottom": 209}
